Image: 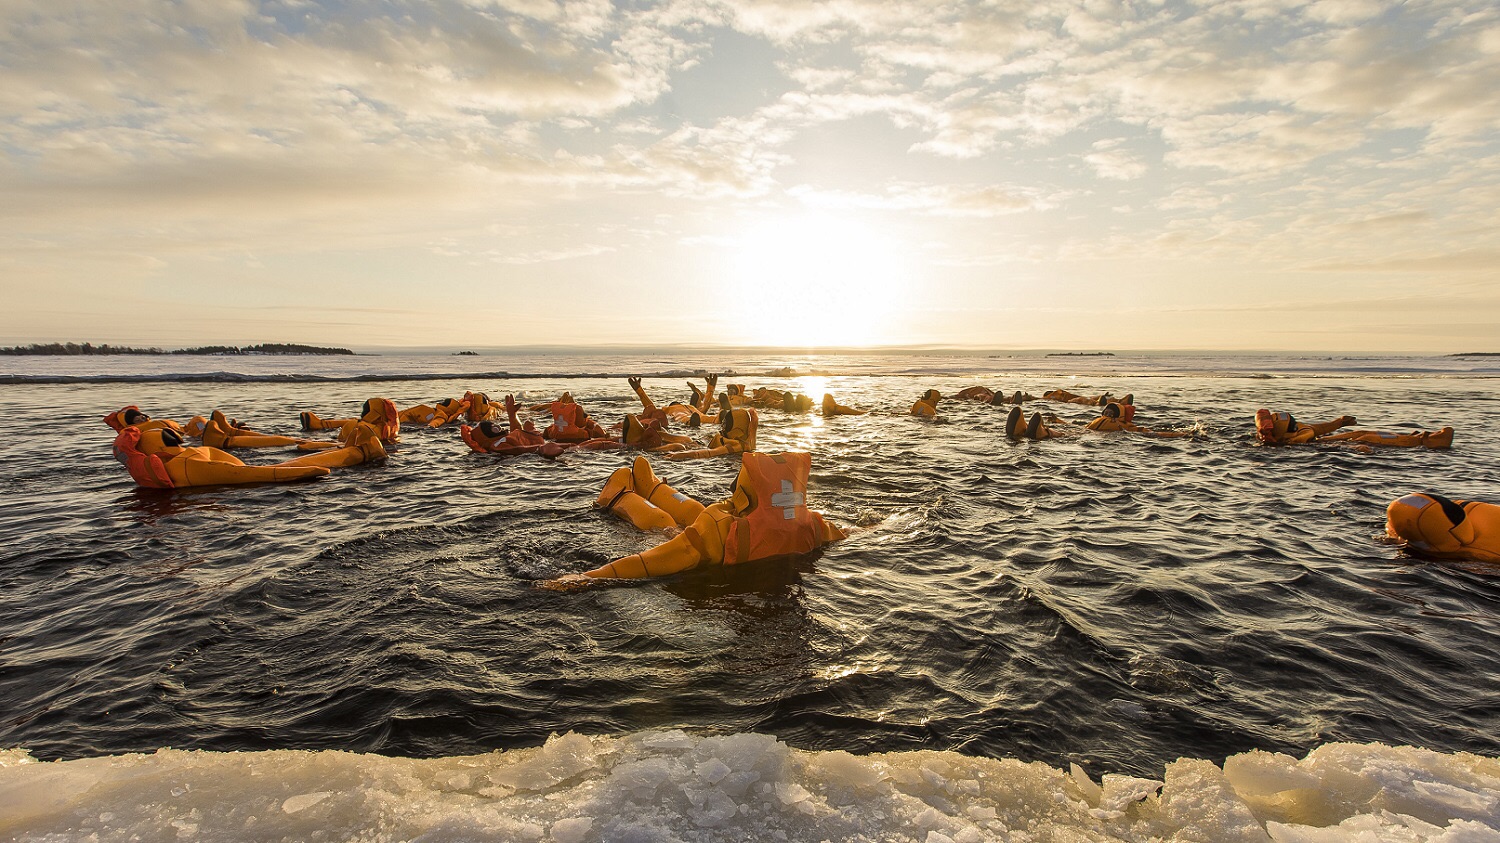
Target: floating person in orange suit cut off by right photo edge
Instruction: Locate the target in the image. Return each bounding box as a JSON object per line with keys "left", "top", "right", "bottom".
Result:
{"left": 1386, "top": 492, "right": 1500, "bottom": 563}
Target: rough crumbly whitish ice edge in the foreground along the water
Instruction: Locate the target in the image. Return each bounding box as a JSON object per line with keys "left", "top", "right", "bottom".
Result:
{"left": 0, "top": 731, "right": 1500, "bottom": 843}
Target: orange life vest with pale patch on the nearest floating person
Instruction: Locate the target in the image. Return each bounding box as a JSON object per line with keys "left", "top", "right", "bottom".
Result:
{"left": 725, "top": 452, "right": 830, "bottom": 566}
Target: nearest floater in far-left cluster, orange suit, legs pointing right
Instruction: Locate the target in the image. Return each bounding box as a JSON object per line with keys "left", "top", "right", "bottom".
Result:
{"left": 114, "top": 426, "right": 330, "bottom": 489}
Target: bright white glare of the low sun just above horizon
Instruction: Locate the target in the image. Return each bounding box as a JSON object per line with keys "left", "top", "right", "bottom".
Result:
{"left": 732, "top": 213, "right": 909, "bottom": 347}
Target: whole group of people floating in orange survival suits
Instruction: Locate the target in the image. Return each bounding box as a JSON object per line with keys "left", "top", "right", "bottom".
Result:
{"left": 104, "top": 375, "right": 1500, "bottom": 576}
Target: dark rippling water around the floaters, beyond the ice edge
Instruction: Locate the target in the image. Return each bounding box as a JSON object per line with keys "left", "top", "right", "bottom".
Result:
{"left": 0, "top": 354, "right": 1500, "bottom": 773}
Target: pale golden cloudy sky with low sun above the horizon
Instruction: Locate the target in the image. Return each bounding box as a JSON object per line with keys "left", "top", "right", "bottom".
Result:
{"left": 0, "top": 0, "right": 1500, "bottom": 353}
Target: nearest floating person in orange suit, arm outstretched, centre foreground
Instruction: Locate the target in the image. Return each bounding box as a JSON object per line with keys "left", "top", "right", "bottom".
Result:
{"left": 537, "top": 452, "right": 846, "bottom": 591}
